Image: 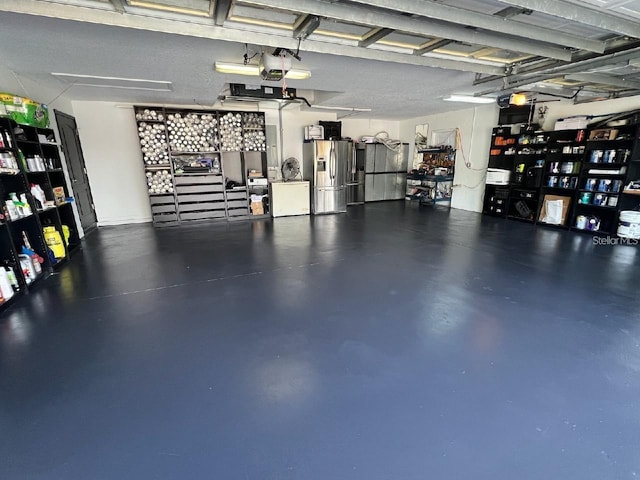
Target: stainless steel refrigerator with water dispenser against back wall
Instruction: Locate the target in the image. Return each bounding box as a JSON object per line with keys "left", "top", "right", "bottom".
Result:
{"left": 302, "top": 140, "right": 353, "bottom": 215}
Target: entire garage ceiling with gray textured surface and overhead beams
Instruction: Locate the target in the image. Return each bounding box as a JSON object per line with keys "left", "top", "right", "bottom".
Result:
{"left": 0, "top": 0, "right": 640, "bottom": 118}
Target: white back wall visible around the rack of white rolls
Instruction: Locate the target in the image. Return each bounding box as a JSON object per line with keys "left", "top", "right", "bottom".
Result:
{"left": 72, "top": 101, "right": 400, "bottom": 225}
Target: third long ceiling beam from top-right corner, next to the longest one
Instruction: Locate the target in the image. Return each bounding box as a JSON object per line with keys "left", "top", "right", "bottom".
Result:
{"left": 244, "top": 0, "right": 571, "bottom": 62}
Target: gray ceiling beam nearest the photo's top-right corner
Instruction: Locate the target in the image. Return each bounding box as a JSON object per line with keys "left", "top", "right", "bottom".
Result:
{"left": 500, "top": 0, "right": 640, "bottom": 38}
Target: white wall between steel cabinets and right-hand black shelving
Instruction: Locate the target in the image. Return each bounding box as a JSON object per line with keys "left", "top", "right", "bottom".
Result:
{"left": 399, "top": 105, "right": 498, "bottom": 212}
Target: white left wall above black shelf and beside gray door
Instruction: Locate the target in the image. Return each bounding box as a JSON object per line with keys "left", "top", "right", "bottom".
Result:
{"left": 0, "top": 69, "right": 84, "bottom": 238}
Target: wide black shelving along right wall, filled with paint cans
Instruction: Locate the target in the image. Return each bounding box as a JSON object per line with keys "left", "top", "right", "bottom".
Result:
{"left": 483, "top": 120, "right": 640, "bottom": 240}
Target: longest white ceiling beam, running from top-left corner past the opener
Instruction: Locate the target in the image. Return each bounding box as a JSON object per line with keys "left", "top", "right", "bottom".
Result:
{"left": 0, "top": 0, "right": 504, "bottom": 75}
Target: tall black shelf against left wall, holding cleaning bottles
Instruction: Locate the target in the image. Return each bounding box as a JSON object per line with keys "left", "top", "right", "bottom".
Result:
{"left": 0, "top": 117, "right": 80, "bottom": 307}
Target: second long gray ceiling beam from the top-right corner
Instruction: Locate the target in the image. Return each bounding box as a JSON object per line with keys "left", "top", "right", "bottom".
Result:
{"left": 353, "top": 0, "right": 605, "bottom": 53}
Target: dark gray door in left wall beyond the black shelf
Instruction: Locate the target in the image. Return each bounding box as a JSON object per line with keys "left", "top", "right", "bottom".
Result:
{"left": 55, "top": 110, "right": 97, "bottom": 233}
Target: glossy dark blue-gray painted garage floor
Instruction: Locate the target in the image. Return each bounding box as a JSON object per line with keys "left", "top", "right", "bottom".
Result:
{"left": 0, "top": 202, "right": 640, "bottom": 480}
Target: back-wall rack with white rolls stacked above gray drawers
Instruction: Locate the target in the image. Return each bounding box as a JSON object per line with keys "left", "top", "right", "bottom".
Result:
{"left": 134, "top": 107, "right": 268, "bottom": 225}
